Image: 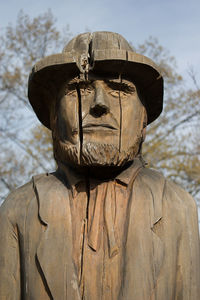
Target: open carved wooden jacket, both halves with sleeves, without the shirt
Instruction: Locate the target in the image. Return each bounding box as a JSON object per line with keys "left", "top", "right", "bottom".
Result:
{"left": 0, "top": 168, "right": 200, "bottom": 300}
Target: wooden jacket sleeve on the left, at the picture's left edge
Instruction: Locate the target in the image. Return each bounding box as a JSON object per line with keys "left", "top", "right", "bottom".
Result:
{"left": 0, "top": 199, "right": 20, "bottom": 300}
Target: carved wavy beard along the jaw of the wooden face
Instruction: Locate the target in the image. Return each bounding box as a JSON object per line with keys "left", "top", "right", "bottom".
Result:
{"left": 53, "top": 137, "right": 142, "bottom": 167}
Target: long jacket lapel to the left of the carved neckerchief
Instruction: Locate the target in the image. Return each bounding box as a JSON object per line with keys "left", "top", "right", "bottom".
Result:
{"left": 33, "top": 175, "right": 80, "bottom": 300}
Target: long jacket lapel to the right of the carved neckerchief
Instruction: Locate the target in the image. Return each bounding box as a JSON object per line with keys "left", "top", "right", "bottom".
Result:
{"left": 120, "top": 168, "right": 164, "bottom": 300}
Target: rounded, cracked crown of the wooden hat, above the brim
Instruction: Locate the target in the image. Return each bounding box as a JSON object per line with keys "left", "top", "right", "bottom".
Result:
{"left": 63, "top": 31, "right": 133, "bottom": 54}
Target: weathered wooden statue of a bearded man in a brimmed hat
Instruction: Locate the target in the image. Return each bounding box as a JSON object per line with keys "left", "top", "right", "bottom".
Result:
{"left": 0, "top": 32, "right": 200, "bottom": 300}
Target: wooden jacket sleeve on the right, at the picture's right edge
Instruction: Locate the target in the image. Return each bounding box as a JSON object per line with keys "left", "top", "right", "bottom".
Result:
{"left": 175, "top": 189, "right": 200, "bottom": 300}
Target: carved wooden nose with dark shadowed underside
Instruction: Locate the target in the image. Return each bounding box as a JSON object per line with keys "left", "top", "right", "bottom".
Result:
{"left": 90, "top": 84, "right": 110, "bottom": 117}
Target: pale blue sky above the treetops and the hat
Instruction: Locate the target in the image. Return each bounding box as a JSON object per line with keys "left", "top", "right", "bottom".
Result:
{"left": 0, "top": 0, "right": 200, "bottom": 82}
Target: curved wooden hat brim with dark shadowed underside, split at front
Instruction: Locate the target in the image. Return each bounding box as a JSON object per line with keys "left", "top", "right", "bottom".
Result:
{"left": 28, "top": 49, "right": 163, "bottom": 129}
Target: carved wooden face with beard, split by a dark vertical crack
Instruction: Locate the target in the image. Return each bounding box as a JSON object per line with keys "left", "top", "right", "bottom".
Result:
{"left": 54, "top": 75, "right": 146, "bottom": 165}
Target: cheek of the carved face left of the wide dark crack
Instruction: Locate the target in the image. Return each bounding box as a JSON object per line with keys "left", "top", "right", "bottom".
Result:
{"left": 57, "top": 95, "right": 78, "bottom": 144}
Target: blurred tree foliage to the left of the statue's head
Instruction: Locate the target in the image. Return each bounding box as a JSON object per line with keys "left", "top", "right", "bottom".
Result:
{"left": 0, "top": 10, "right": 71, "bottom": 202}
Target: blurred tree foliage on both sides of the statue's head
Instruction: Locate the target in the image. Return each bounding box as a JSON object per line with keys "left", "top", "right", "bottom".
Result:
{"left": 0, "top": 11, "right": 200, "bottom": 201}
